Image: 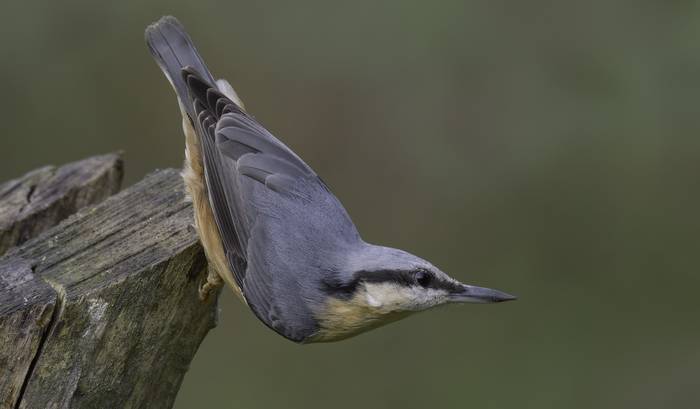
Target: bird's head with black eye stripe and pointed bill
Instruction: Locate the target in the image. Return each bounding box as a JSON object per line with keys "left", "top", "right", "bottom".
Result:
{"left": 314, "top": 245, "right": 516, "bottom": 341}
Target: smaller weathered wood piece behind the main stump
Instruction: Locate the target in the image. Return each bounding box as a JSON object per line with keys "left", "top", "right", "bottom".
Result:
{"left": 0, "top": 154, "right": 123, "bottom": 255}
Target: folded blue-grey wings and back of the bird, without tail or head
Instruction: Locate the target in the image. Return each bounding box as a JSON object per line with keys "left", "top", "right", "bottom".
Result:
{"left": 183, "top": 69, "right": 359, "bottom": 338}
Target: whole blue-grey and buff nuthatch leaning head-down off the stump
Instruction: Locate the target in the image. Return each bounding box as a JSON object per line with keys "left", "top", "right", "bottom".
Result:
{"left": 145, "top": 16, "right": 516, "bottom": 344}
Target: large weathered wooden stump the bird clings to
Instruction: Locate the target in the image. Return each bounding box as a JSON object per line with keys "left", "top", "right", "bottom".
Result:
{"left": 0, "top": 163, "right": 217, "bottom": 409}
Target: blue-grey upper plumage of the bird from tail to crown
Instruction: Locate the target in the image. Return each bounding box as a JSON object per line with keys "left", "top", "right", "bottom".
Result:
{"left": 146, "top": 17, "right": 516, "bottom": 342}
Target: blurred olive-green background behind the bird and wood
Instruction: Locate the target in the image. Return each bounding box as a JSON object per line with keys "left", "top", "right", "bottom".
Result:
{"left": 0, "top": 0, "right": 700, "bottom": 409}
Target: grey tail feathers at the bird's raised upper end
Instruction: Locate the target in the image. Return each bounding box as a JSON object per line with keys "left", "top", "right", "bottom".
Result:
{"left": 146, "top": 16, "right": 216, "bottom": 119}
